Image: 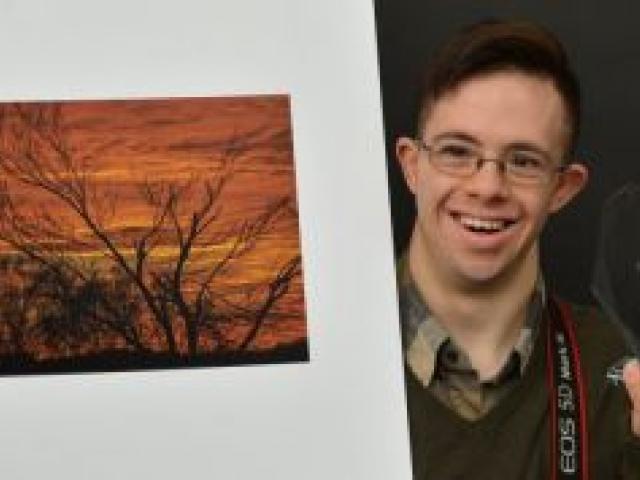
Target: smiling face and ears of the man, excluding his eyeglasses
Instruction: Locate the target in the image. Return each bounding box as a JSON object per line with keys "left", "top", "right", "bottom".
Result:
{"left": 396, "top": 71, "right": 587, "bottom": 285}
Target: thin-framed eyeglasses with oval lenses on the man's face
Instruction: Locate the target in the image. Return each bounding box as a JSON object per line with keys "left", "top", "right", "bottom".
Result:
{"left": 416, "top": 139, "right": 565, "bottom": 185}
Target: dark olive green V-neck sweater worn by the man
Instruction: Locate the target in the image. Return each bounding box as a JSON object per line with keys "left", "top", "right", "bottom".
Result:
{"left": 405, "top": 307, "right": 640, "bottom": 480}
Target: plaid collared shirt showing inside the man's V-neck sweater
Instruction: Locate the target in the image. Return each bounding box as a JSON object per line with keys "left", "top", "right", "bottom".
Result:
{"left": 398, "top": 255, "right": 545, "bottom": 420}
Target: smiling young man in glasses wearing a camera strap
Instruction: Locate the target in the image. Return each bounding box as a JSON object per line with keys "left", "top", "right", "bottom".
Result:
{"left": 396, "top": 22, "right": 640, "bottom": 480}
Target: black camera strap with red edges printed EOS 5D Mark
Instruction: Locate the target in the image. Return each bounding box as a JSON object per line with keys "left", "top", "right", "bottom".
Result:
{"left": 547, "top": 299, "right": 589, "bottom": 480}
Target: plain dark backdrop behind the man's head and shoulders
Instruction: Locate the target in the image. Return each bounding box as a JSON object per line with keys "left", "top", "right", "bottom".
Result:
{"left": 375, "top": 0, "right": 640, "bottom": 303}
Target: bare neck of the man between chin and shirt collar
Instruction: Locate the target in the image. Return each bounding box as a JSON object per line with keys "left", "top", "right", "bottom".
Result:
{"left": 409, "top": 232, "right": 539, "bottom": 380}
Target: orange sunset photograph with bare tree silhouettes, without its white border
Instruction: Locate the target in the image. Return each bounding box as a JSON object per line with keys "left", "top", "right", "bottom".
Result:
{"left": 0, "top": 95, "right": 309, "bottom": 375}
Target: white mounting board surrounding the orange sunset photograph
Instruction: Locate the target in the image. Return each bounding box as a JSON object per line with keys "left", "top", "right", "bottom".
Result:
{"left": 0, "top": 0, "right": 411, "bottom": 480}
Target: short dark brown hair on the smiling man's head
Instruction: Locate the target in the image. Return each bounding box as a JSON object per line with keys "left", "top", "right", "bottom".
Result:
{"left": 414, "top": 20, "right": 580, "bottom": 152}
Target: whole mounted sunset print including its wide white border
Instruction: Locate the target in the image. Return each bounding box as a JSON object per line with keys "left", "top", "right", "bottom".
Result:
{"left": 0, "top": 0, "right": 411, "bottom": 480}
